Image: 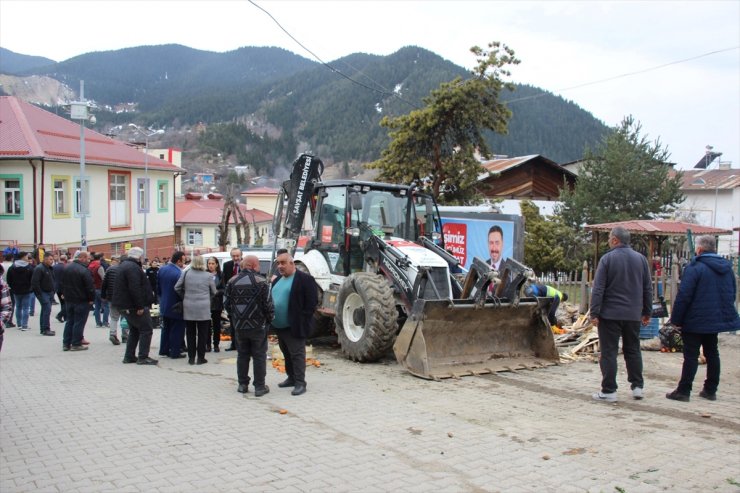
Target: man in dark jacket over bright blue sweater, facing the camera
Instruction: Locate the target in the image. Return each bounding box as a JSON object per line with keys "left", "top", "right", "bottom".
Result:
{"left": 272, "top": 253, "right": 318, "bottom": 395}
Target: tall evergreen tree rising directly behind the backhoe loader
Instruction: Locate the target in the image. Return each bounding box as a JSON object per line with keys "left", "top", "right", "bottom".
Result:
{"left": 368, "top": 42, "right": 519, "bottom": 202}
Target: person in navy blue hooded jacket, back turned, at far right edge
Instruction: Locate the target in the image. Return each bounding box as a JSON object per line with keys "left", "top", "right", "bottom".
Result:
{"left": 666, "top": 235, "right": 740, "bottom": 402}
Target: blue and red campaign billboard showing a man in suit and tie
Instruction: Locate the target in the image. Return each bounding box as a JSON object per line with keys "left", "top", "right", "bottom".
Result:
{"left": 440, "top": 212, "right": 524, "bottom": 269}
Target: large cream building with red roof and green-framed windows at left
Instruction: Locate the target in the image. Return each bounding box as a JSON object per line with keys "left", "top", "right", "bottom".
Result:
{"left": 0, "top": 96, "right": 184, "bottom": 257}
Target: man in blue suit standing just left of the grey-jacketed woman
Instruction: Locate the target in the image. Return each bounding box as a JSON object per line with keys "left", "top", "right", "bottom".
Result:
{"left": 157, "top": 252, "right": 185, "bottom": 358}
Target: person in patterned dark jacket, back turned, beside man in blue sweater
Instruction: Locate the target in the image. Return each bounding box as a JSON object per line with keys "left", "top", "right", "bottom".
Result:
{"left": 226, "top": 255, "right": 274, "bottom": 397}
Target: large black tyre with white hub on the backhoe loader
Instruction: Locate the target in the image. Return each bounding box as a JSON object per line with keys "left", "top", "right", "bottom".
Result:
{"left": 334, "top": 272, "right": 398, "bottom": 362}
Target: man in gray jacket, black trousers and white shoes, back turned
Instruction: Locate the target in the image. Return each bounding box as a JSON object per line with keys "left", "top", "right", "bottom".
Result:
{"left": 591, "top": 226, "right": 653, "bottom": 402}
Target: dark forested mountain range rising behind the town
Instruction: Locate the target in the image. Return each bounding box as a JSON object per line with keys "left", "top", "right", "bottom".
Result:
{"left": 0, "top": 45, "right": 606, "bottom": 167}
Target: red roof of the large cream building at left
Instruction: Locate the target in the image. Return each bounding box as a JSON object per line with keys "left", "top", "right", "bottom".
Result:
{"left": 0, "top": 96, "right": 183, "bottom": 172}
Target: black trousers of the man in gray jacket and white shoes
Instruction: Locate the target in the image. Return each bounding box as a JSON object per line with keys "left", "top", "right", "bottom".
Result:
{"left": 599, "top": 318, "right": 644, "bottom": 394}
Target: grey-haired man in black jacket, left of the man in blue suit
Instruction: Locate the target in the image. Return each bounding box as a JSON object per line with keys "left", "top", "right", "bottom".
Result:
{"left": 112, "top": 247, "right": 158, "bottom": 365}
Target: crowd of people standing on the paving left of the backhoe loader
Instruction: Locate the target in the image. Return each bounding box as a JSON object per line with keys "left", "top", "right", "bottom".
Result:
{"left": 0, "top": 247, "right": 318, "bottom": 397}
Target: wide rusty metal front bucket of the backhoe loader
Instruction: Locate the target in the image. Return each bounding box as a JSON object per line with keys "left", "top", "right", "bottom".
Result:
{"left": 393, "top": 298, "right": 559, "bottom": 380}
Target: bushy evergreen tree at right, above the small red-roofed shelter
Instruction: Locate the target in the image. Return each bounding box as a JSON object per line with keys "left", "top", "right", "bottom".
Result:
{"left": 556, "top": 116, "right": 684, "bottom": 227}
